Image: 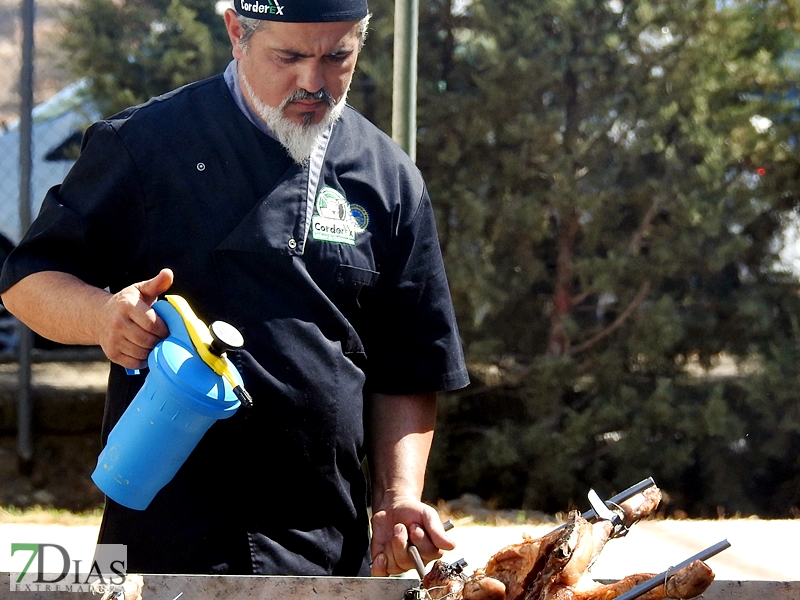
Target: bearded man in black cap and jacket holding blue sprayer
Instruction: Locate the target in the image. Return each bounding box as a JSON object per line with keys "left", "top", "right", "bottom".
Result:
{"left": 0, "top": 0, "right": 467, "bottom": 576}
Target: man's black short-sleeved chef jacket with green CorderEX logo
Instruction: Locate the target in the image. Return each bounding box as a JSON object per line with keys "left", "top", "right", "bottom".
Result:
{"left": 0, "top": 76, "right": 467, "bottom": 575}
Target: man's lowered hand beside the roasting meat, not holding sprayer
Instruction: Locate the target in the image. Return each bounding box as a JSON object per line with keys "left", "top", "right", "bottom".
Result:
{"left": 370, "top": 498, "right": 455, "bottom": 577}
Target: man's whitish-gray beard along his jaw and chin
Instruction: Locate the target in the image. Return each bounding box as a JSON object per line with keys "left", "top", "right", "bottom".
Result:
{"left": 239, "top": 71, "right": 347, "bottom": 165}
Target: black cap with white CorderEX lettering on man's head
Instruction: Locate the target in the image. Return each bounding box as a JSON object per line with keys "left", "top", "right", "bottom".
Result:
{"left": 233, "top": 0, "right": 369, "bottom": 23}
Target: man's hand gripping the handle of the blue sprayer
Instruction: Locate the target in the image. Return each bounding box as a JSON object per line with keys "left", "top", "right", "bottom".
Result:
{"left": 98, "top": 269, "right": 174, "bottom": 369}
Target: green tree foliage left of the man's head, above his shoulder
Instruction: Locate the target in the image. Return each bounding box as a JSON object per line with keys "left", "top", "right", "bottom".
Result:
{"left": 61, "top": 0, "right": 231, "bottom": 115}
